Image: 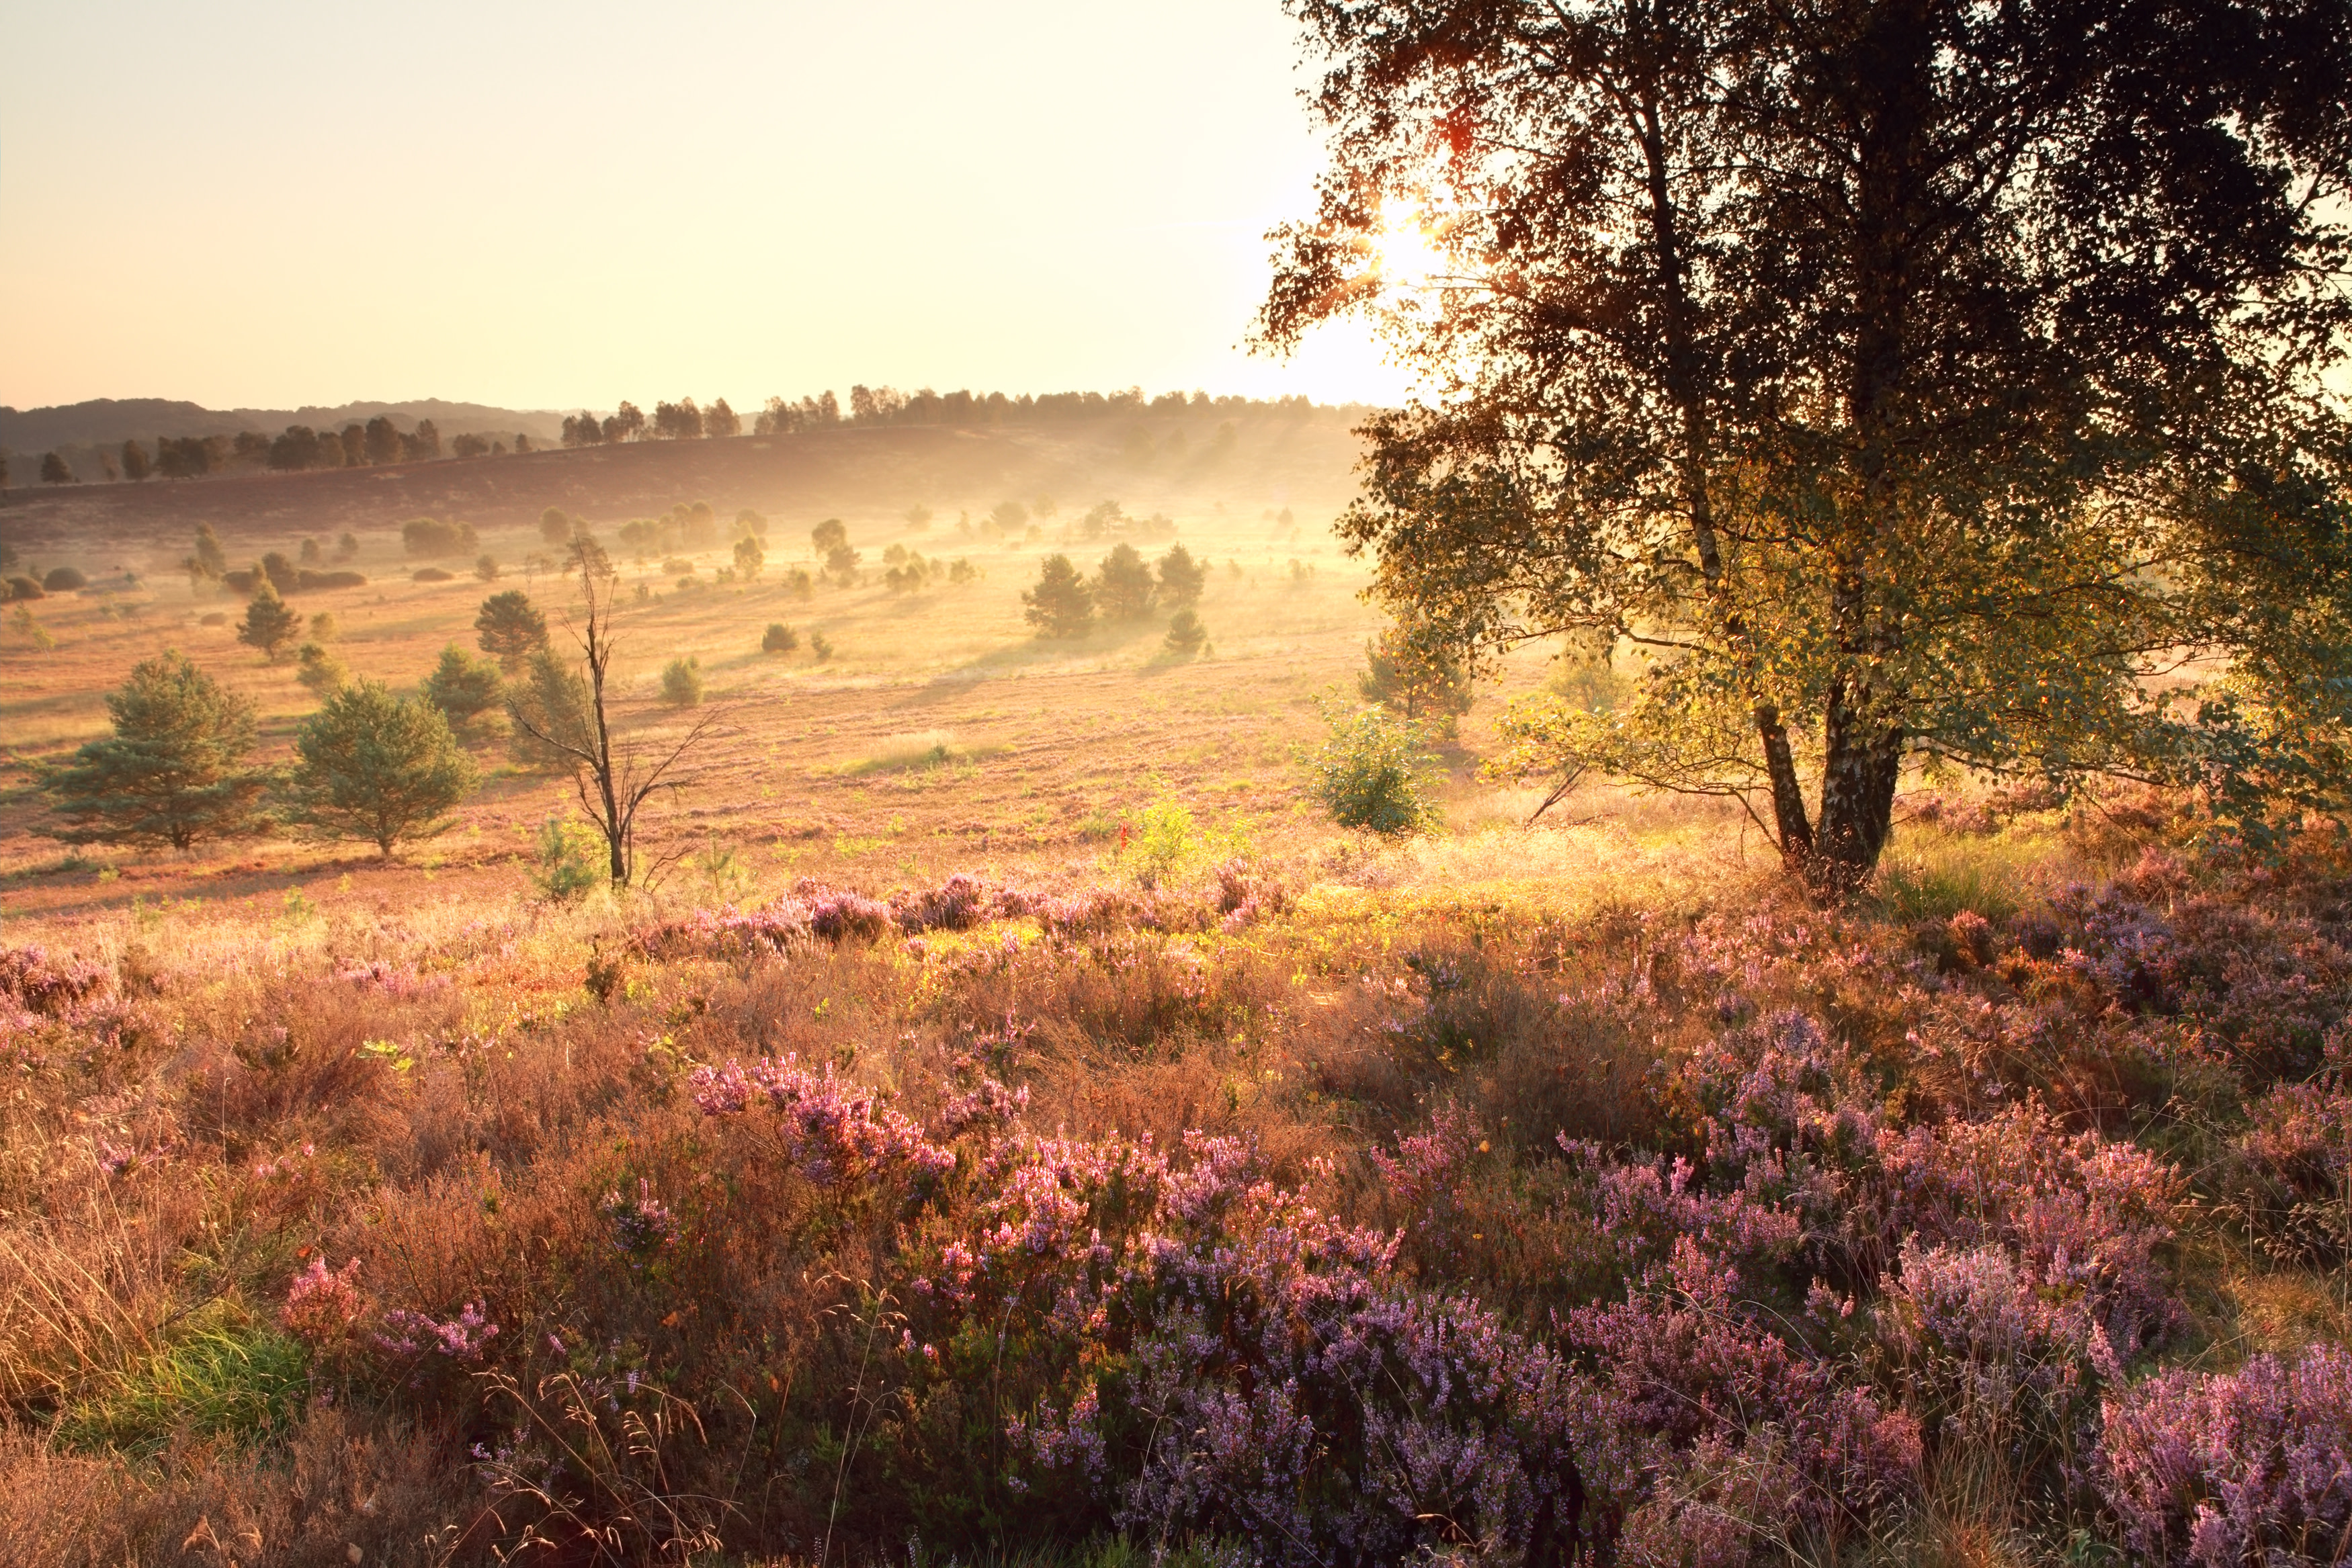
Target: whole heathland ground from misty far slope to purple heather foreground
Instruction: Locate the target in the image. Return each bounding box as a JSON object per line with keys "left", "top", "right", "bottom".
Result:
{"left": 0, "top": 409, "right": 2352, "bottom": 1568}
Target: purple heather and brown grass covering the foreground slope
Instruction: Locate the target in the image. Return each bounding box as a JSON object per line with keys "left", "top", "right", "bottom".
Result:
{"left": 13, "top": 806, "right": 2352, "bottom": 1563}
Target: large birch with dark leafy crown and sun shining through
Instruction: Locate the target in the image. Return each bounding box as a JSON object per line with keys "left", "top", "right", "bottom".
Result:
{"left": 1261, "top": 0, "right": 2352, "bottom": 891}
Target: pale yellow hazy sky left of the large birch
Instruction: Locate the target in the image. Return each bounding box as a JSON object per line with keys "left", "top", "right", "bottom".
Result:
{"left": 0, "top": 0, "right": 1400, "bottom": 409}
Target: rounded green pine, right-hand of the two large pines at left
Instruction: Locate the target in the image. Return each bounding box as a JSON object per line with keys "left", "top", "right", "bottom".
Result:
{"left": 287, "top": 679, "right": 480, "bottom": 856}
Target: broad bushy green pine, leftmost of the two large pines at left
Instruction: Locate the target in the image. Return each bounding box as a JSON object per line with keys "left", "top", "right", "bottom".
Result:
{"left": 42, "top": 651, "right": 268, "bottom": 848}
